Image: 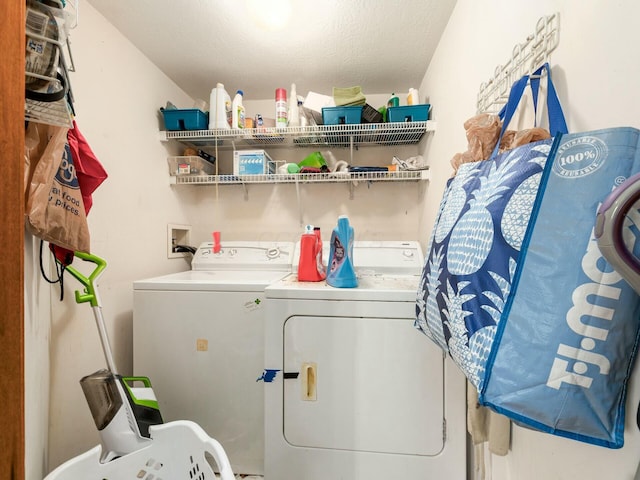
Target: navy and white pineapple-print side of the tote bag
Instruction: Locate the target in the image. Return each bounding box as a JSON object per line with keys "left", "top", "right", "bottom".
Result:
{"left": 415, "top": 139, "right": 553, "bottom": 390}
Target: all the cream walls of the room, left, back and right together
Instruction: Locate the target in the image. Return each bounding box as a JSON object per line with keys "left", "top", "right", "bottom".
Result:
{"left": 26, "top": 0, "right": 640, "bottom": 480}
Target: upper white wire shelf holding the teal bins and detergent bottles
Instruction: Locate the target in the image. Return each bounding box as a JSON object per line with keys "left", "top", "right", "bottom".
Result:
{"left": 160, "top": 121, "right": 435, "bottom": 148}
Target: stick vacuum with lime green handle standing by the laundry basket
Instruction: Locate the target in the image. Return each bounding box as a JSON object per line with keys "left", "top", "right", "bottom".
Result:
{"left": 66, "top": 252, "right": 162, "bottom": 463}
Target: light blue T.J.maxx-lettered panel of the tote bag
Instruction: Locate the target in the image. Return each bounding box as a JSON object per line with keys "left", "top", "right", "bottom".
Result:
{"left": 479, "top": 127, "right": 640, "bottom": 448}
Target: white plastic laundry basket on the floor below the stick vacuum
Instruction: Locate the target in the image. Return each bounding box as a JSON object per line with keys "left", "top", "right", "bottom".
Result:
{"left": 44, "top": 420, "right": 235, "bottom": 480}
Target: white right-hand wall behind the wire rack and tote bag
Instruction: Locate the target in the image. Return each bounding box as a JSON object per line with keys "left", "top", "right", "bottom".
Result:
{"left": 421, "top": 0, "right": 640, "bottom": 480}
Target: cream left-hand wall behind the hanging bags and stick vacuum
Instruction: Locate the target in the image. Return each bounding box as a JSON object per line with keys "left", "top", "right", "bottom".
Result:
{"left": 40, "top": 2, "right": 191, "bottom": 480}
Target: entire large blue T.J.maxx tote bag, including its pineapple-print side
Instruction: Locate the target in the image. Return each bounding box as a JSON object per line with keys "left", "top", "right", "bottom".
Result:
{"left": 416, "top": 62, "right": 640, "bottom": 448}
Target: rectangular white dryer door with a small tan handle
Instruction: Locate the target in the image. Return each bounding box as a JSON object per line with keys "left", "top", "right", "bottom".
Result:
{"left": 283, "top": 316, "right": 444, "bottom": 455}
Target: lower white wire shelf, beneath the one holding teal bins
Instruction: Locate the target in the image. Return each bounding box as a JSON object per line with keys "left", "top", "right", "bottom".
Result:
{"left": 172, "top": 170, "right": 430, "bottom": 185}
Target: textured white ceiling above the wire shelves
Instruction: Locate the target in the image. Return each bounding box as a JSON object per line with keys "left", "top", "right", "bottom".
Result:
{"left": 88, "top": 0, "right": 455, "bottom": 100}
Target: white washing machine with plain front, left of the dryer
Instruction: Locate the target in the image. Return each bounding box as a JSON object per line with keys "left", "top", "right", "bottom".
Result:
{"left": 133, "top": 242, "right": 294, "bottom": 475}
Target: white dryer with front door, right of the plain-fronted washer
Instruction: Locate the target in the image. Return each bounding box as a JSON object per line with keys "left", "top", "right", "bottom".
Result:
{"left": 265, "top": 242, "right": 466, "bottom": 480}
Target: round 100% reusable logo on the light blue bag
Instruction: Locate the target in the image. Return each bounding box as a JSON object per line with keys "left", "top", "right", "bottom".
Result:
{"left": 553, "top": 136, "right": 609, "bottom": 178}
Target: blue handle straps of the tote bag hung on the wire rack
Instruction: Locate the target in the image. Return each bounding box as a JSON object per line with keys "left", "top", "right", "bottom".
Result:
{"left": 490, "top": 63, "right": 568, "bottom": 158}
